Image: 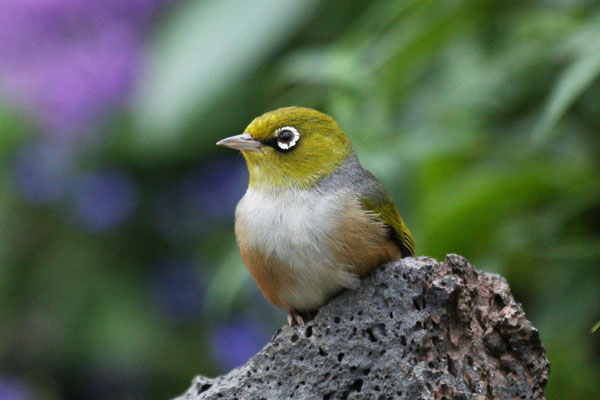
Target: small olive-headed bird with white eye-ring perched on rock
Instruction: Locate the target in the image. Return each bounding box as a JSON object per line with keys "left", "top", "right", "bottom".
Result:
{"left": 217, "top": 107, "right": 414, "bottom": 326}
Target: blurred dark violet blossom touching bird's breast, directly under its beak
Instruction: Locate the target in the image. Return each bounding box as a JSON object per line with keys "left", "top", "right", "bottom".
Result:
{"left": 156, "top": 157, "right": 248, "bottom": 239}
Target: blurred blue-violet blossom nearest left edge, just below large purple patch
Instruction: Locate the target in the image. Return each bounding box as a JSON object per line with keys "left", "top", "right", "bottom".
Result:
{"left": 13, "top": 141, "right": 72, "bottom": 204}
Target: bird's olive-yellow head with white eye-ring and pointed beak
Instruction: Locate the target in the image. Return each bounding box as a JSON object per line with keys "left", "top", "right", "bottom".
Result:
{"left": 217, "top": 107, "right": 352, "bottom": 188}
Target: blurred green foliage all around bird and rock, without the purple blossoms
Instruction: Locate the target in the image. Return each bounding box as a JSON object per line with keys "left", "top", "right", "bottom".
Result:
{"left": 0, "top": 0, "right": 600, "bottom": 399}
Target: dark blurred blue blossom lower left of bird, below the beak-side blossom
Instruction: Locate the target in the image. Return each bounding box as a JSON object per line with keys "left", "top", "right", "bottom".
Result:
{"left": 152, "top": 259, "right": 204, "bottom": 319}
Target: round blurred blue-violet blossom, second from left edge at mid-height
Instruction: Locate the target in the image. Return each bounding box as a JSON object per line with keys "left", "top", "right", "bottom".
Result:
{"left": 74, "top": 171, "right": 137, "bottom": 231}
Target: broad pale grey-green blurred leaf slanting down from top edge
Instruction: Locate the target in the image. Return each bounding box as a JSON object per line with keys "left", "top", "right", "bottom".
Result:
{"left": 132, "top": 0, "right": 314, "bottom": 158}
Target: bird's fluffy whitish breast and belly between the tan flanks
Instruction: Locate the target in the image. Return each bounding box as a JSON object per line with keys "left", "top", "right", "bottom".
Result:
{"left": 236, "top": 188, "right": 358, "bottom": 310}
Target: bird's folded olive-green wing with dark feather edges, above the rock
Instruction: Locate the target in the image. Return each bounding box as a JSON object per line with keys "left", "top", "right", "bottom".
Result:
{"left": 360, "top": 190, "right": 415, "bottom": 257}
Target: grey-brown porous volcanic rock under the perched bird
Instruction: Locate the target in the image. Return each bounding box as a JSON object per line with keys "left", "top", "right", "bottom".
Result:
{"left": 173, "top": 254, "right": 550, "bottom": 400}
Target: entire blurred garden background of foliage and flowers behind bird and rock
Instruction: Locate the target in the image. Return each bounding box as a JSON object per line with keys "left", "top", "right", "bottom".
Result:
{"left": 0, "top": 0, "right": 600, "bottom": 400}
